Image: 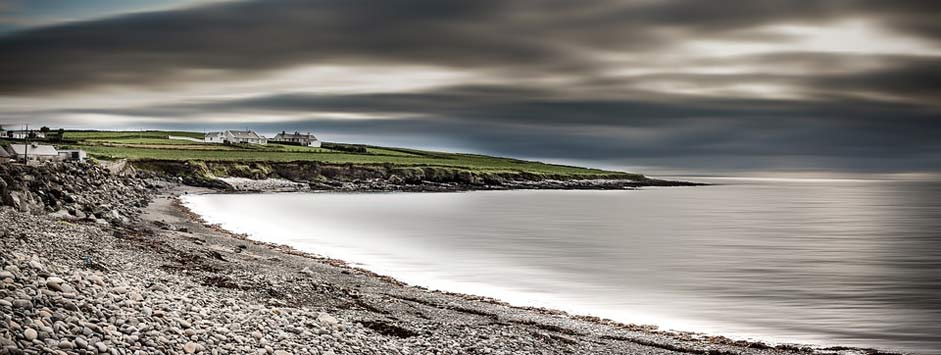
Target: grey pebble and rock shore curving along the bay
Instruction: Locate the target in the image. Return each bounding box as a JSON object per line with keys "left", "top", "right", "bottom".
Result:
{"left": 0, "top": 165, "right": 908, "bottom": 355}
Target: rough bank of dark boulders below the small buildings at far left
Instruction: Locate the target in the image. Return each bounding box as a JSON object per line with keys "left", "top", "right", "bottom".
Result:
{"left": 0, "top": 162, "right": 166, "bottom": 223}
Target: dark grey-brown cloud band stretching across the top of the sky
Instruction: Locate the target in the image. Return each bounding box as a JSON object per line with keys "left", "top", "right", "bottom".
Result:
{"left": 0, "top": 0, "right": 941, "bottom": 94}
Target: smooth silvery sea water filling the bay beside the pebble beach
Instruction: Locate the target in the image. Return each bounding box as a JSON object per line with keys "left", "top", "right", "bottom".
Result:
{"left": 185, "top": 179, "right": 941, "bottom": 353}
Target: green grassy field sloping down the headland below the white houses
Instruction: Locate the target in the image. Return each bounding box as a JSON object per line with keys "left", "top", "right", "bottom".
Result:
{"left": 60, "top": 131, "right": 626, "bottom": 177}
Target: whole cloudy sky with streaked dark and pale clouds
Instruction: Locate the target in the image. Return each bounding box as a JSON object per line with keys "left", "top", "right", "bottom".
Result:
{"left": 0, "top": 0, "right": 941, "bottom": 174}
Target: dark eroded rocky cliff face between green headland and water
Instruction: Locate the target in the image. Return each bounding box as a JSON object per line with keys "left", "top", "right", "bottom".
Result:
{"left": 132, "top": 160, "right": 656, "bottom": 190}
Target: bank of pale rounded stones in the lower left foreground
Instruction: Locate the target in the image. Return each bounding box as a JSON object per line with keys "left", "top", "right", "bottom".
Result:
{"left": 0, "top": 208, "right": 388, "bottom": 355}
